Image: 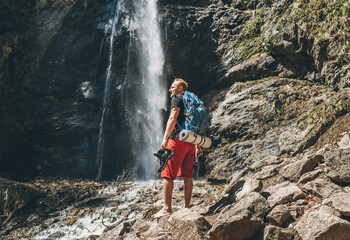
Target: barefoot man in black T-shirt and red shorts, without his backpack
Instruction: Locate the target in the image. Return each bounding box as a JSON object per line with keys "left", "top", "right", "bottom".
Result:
{"left": 153, "top": 78, "right": 201, "bottom": 219}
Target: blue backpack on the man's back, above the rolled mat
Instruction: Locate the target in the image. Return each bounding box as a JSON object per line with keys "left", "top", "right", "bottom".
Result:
{"left": 181, "top": 91, "right": 209, "bottom": 135}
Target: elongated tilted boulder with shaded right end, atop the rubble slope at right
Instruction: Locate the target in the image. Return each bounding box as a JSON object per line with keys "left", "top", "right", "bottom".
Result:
{"left": 280, "top": 155, "right": 323, "bottom": 181}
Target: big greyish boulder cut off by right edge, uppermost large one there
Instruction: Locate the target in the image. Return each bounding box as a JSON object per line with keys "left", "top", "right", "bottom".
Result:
{"left": 325, "top": 148, "right": 350, "bottom": 183}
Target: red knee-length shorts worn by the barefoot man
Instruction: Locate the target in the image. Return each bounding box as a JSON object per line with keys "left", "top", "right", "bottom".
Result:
{"left": 161, "top": 138, "right": 195, "bottom": 180}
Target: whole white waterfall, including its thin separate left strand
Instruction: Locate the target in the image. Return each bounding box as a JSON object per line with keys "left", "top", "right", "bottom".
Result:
{"left": 97, "top": 0, "right": 167, "bottom": 180}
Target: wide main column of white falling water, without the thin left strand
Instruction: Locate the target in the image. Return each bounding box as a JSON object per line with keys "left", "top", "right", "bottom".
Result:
{"left": 129, "top": 0, "right": 167, "bottom": 177}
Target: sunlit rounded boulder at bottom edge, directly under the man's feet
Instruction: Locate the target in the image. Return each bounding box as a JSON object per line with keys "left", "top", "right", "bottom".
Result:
{"left": 168, "top": 208, "right": 211, "bottom": 240}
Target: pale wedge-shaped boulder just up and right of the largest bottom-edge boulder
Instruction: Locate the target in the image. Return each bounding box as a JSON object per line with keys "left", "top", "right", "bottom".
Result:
{"left": 264, "top": 182, "right": 305, "bottom": 207}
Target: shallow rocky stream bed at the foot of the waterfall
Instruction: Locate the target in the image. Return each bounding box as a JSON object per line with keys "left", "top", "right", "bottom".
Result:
{"left": 0, "top": 175, "right": 223, "bottom": 239}
